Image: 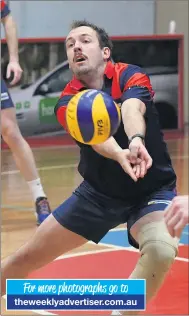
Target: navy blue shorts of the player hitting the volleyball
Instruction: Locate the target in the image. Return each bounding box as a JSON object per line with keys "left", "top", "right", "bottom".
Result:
{"left": 53, "top": 181, "right": 176, "bottom": 248}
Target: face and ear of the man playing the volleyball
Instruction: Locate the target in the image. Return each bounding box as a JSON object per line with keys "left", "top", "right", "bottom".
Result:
{"left": 66, "top": 26, "right": 110, "bottom": 78}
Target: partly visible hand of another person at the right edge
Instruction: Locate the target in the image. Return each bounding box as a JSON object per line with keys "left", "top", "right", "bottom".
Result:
{"left": 164, "top": 195, "right": 189, "bottom": 238}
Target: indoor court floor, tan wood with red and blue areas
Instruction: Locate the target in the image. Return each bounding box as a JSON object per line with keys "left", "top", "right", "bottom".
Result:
{"left": 1, "top": 137, "right": 189, "bottom": 315}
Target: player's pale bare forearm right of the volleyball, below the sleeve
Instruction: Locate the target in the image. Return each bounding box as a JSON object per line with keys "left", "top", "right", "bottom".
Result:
{"left": 122, "top": 99, "right": 146, "bottom": 137}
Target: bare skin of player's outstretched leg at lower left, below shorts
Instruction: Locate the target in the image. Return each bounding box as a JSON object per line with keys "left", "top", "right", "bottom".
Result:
{"left": 1, "top": 215, "right": 87, "bottom": 296}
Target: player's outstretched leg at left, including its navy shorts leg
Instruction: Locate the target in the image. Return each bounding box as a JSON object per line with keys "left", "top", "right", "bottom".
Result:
{"left": 1, "top": 183, "right": 117, "bottom": 295}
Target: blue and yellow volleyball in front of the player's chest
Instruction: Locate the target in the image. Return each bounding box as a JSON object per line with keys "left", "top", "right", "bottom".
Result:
{"left": 66, "top": 89, "right": 121, "bottom": 145}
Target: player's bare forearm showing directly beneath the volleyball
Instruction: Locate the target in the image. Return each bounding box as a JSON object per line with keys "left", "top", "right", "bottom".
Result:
{"left": 92, "top": 137, "right": 122, "bottom": 160}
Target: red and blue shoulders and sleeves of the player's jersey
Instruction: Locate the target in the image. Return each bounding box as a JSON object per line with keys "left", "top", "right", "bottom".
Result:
{"left": 55, "top": 61, "right": 154, "bottom": 128}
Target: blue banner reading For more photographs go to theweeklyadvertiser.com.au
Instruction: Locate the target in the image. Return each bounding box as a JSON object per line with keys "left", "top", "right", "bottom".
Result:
{"left": 6, "top": 279, "right": 146, "bottom": 310}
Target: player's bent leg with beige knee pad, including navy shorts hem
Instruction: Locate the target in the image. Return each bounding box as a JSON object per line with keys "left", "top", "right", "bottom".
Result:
{"left": 116, "top": 189, "right": 178, "bottom": 315}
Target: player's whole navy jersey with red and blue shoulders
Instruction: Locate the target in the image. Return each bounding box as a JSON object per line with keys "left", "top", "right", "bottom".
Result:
{"left": 55, "top": 61, "right": 176, "bottom": 200}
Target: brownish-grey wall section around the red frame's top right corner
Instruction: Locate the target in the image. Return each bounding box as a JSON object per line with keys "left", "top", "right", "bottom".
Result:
{"left": 155, "top": 0, "right": 189, "bottom": 123}
